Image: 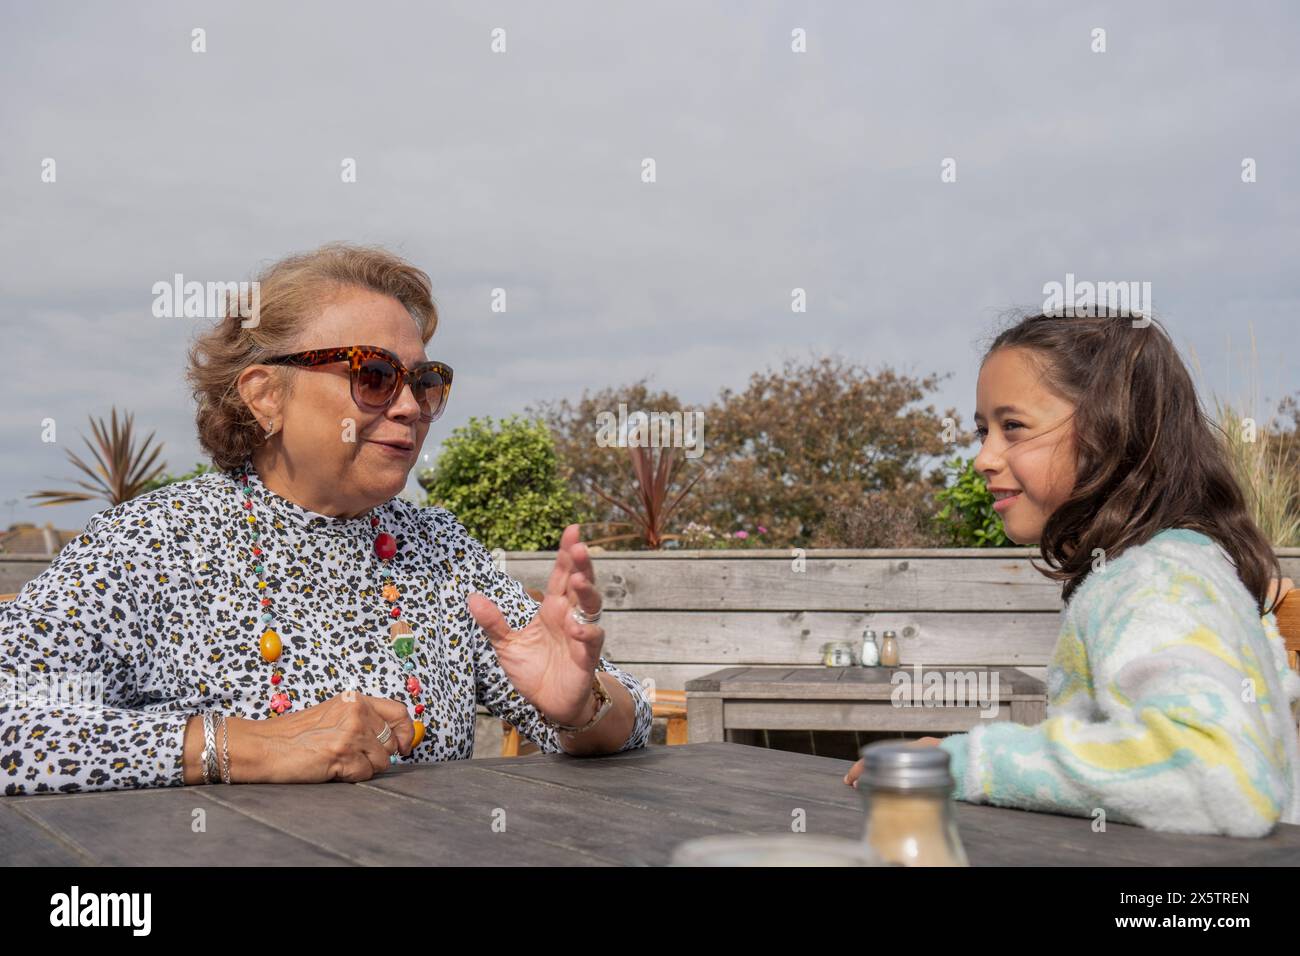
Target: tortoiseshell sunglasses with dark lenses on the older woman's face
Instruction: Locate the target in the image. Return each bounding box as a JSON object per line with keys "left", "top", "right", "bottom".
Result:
{"left": 259, "top": 345, "right": 451, "bottom": 421}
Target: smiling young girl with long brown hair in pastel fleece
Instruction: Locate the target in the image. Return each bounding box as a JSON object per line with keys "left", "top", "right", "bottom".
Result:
{"left": 845, "top": 315, "right": 1300, "bottom": 836}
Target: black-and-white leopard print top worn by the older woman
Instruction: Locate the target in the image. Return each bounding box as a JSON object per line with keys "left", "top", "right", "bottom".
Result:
{"left": 0, "top": 467, "right": 651, "bottom": 795}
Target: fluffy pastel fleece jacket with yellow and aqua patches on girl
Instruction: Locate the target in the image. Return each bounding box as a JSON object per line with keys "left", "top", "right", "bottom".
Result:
{"left": 940, "top": 528, "right": 1300, "bottom": 836}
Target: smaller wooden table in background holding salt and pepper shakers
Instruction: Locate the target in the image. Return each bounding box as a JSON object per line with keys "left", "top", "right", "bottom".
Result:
{"left": 686, "top": 666, "right": 1047, "bottom": 744}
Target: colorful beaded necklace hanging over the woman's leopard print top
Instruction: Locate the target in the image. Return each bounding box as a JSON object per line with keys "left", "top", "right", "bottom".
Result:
{"left": 235, "top": 464, "right": 425, "bottom": 763}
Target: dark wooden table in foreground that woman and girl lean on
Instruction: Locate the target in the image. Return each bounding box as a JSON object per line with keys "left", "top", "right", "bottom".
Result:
{"left": 0, "top": 743, "right": 1300, "bottom": 866}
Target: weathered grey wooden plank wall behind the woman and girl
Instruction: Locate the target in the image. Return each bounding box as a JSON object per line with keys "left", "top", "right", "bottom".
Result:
{"left": 10, "top": 548, "right": 1300, "bottom": 689}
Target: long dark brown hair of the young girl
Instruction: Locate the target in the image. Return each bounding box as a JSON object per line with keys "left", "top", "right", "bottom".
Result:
{"left": 984, "top": 315, "right": 1282, "bottom": 614}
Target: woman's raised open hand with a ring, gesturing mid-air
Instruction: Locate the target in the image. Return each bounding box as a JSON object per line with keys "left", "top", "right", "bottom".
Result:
{"left": 468, "top": 524, "right": 605, "bottom": 724}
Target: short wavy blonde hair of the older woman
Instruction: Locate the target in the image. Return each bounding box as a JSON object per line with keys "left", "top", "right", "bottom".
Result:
{"left": 186, "top": 242, "right": 438, "bottom": 470}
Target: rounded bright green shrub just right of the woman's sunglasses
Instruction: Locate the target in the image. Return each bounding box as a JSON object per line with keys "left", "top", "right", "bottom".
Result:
{"left": 420, "top": 415, "right": 580, "bottom": 551}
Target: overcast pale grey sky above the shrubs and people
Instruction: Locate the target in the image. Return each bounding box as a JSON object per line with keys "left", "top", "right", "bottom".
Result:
{"left": 0, "top": 0, "right": 1300, "bottom": 528}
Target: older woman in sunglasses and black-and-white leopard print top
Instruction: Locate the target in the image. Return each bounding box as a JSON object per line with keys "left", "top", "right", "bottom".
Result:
{"left": 0, "top": 245, "right": 651, "bottom": 795}
